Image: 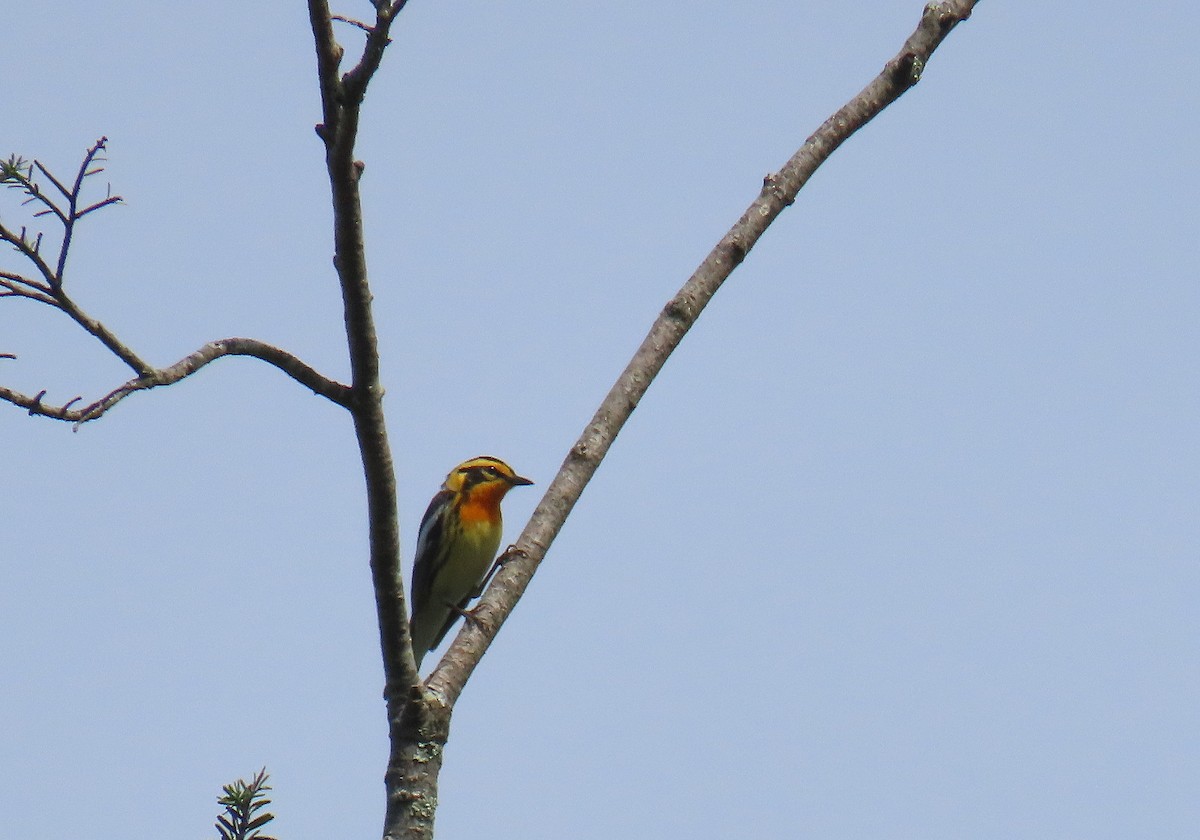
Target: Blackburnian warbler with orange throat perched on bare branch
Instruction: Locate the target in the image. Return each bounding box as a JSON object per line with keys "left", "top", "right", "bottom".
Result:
{"left": 409, "top": 455, "right": 533, "bottom": 667}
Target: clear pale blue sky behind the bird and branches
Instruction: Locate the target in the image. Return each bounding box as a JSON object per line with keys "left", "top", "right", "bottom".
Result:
{"left": 0, "top": 0, "right": 1200, "bottom": 840}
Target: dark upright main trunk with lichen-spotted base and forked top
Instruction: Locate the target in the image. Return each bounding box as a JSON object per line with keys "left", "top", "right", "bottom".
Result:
{"left": 308, "top": 0, "right": 450, "bottom": 838}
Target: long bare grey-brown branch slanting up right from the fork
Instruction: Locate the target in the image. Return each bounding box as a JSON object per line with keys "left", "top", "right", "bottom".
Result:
{"left": 427, "top": 0, "right": 978, "bottom": 704}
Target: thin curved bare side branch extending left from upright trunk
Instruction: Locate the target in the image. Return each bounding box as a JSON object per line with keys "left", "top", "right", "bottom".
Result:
{"left": 0, "top": 338, "right": 350, "bottom": 426}
